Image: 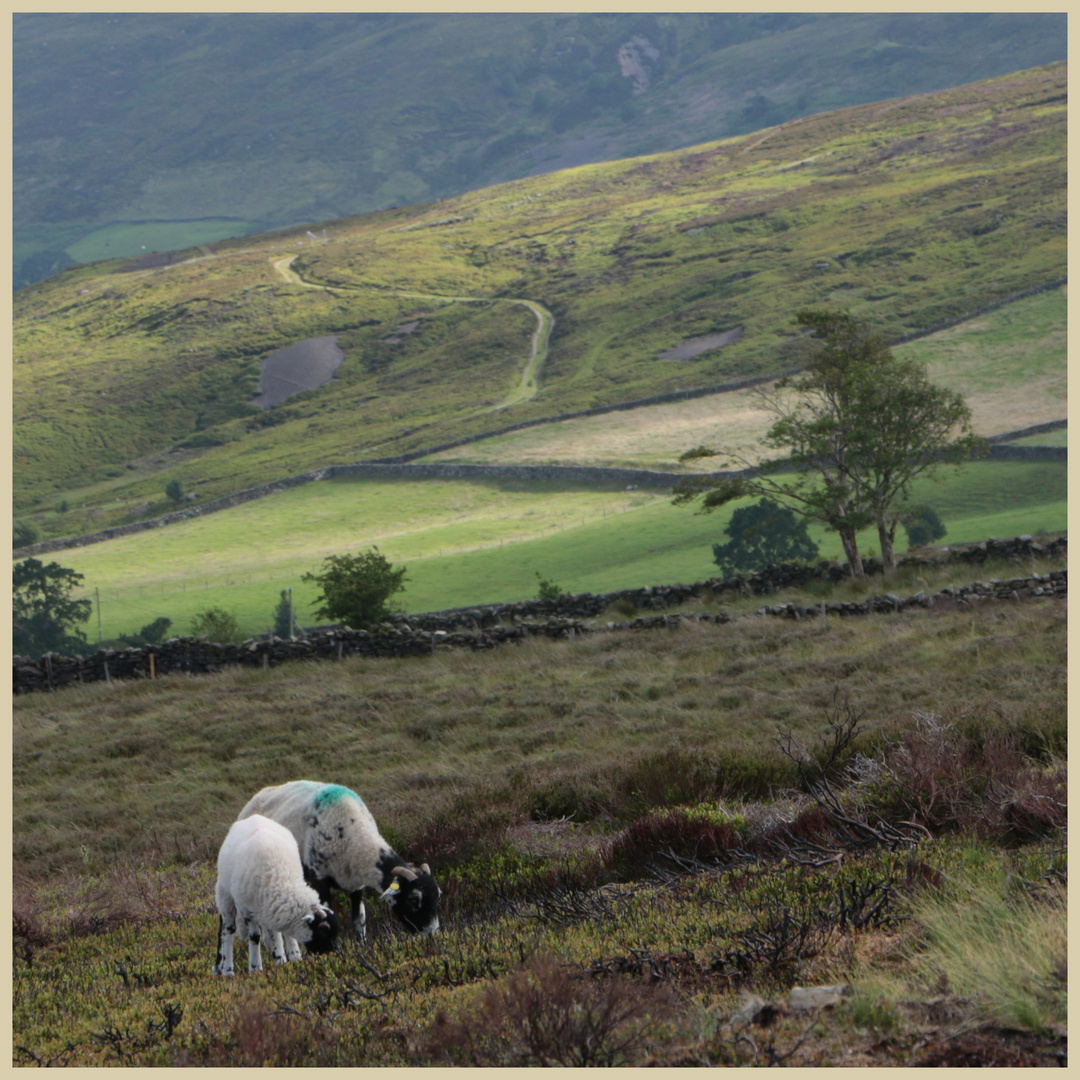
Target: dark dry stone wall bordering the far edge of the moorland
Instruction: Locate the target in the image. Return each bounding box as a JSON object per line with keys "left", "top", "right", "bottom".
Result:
{"left": 13, "top": 537, "right": 1068, "bottom": 693}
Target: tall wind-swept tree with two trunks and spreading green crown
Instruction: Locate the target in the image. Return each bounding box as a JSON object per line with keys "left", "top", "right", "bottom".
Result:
{"left": 675, "top": 309, "right": 985, "bottom": 577}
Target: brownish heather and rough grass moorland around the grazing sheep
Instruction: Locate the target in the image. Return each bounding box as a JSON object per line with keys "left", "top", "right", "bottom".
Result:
{"left": 13, "top": 561, "right": 1067, "bottom": 1066}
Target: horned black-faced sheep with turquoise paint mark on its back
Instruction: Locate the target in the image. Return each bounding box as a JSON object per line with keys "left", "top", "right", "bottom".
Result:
{"left": 240, "top": 780, "right": 440, "bottom": 941}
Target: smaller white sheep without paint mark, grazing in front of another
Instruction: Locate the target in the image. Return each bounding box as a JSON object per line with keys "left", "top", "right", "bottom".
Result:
{"left": 214, "top": 814, "right": 340, "bottom": 975}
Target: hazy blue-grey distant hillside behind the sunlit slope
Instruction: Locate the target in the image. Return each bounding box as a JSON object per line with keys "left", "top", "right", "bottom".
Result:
{"left": 13, "top": 12, "right": 1066, "bottom": 286}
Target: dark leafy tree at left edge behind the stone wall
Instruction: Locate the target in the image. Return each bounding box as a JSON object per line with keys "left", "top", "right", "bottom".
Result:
{"left": 12, "top": 558, "right": 94, "bottom": 657}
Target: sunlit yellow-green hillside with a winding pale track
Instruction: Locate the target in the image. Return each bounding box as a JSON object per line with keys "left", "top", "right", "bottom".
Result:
{"left": 14, "top": 66, "right": 1066, "bottom": 534}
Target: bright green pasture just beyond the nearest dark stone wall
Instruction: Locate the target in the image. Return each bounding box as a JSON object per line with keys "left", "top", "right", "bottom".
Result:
{"left": 63, "top": 462, "right": 1067, "bottom": 643}
